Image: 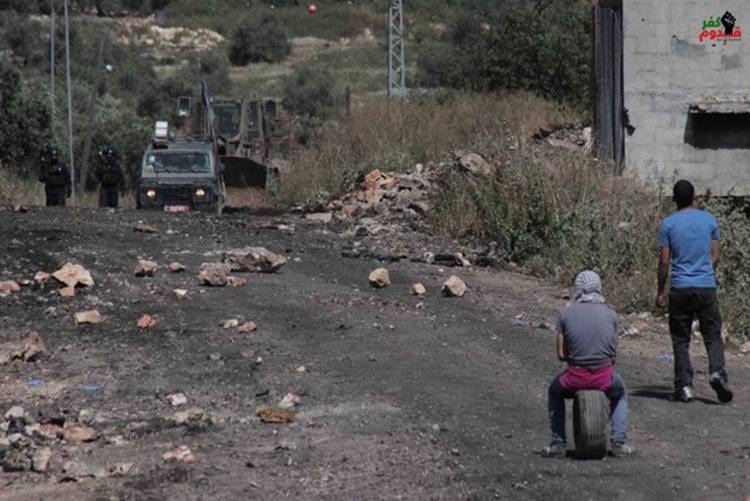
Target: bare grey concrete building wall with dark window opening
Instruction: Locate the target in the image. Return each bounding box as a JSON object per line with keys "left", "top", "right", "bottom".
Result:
{"left": 623, "top": 0, "right": 750, "bottom": 195}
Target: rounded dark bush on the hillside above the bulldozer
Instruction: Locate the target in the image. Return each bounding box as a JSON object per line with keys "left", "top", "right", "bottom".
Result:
{"left": 229, "top": 14, "right": 292, "bottom": 66}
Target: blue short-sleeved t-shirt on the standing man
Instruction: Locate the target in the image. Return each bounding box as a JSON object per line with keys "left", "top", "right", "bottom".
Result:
{"left": 659, "top": 209, "right": 719, "bottom": 289}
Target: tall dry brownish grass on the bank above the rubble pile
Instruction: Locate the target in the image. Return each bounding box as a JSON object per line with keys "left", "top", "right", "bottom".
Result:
{"left": 281, "top": 94, "right": 566, "bottom": 203}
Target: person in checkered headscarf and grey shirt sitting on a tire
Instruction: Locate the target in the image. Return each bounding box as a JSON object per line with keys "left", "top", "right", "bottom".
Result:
{"left": 543, "top": 271, "right": 633, "bottom": 457}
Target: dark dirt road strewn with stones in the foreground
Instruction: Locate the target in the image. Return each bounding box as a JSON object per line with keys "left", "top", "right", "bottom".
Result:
{"left": 0, "top": 205, "right": 750, "bottom": 500}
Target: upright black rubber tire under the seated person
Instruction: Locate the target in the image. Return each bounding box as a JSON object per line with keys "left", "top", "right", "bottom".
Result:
{"left": 573, "top": 390, "right": 609, "bottom": 459}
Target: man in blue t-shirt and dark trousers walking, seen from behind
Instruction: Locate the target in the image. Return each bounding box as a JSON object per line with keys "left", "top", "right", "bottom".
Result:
{"left": 656, "top": 180, "right": 733, "bottom": 403}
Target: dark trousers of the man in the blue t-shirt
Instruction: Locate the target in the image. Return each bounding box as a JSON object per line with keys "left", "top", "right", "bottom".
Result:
{"left": 669, "top": 288, "right": 724, "bottom": 390}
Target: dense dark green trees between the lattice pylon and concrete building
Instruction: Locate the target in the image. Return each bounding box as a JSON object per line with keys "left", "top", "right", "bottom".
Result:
{"left": 418, "top": 1, "right": 592, "bottom": 108}
